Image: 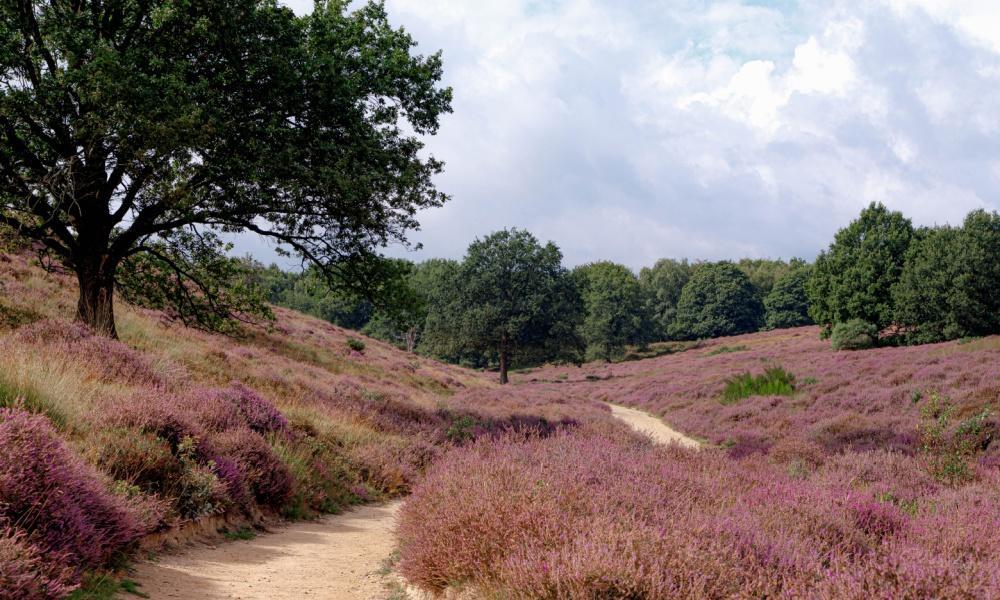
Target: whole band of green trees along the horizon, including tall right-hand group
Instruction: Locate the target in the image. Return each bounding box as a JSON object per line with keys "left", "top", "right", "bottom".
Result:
{"left": 257, "top": 204, "right": 1000, "bottom": 381}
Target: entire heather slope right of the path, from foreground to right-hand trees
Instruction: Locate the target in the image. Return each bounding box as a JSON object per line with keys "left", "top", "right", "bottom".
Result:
{"left": 399, "top": 328, "right": 1000, "bottom": 600}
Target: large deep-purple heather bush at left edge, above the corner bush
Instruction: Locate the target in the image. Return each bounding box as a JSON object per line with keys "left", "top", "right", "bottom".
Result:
{"left": 0, "top": 409, "right": 145, "bottom": 567}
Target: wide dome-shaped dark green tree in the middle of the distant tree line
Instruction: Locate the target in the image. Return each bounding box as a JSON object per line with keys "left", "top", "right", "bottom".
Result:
{"left": 670, "top": 262, "right": 764, "bottom": 339}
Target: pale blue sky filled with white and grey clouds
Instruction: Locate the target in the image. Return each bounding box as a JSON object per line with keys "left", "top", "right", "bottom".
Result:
{"left": 254, "top": 0, "right": 1000, "bottom": 269}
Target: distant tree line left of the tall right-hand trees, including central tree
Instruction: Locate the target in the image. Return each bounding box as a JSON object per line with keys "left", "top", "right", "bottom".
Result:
{"left": 256, "top": 229, "right": 811, "bottom": 381}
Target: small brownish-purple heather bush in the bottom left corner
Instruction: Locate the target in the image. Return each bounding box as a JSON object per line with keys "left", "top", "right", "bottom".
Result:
{"left": 0, "top": 527, "right": 76, "bottom": 600}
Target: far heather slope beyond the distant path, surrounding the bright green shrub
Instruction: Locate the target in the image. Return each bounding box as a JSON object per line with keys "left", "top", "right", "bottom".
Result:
{"left": 530, "top": 327, "right": 1000, "bottom": 454}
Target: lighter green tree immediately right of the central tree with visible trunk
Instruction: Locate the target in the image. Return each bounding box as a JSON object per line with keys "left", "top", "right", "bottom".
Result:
{"left": 573, "top": 261, "right": 650, "bottom": 362}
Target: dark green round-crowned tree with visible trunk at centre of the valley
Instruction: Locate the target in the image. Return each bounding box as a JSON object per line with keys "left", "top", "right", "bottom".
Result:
{"left": 445, "top": 229, "right": 579, "bottom": 383}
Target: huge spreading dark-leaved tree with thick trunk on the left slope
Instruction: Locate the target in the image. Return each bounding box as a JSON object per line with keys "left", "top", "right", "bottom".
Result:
{"left": 0, "top": 0, "right": 451, "bottom": 336}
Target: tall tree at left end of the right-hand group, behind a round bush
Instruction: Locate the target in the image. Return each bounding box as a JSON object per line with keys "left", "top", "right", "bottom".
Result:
{"left": 806, "top": 203, "right": 913, "bottom": 331}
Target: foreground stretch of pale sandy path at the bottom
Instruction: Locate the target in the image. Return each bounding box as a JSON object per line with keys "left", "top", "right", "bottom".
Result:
{"left": 129, "top": 502, "right": 402, "bottom": 600}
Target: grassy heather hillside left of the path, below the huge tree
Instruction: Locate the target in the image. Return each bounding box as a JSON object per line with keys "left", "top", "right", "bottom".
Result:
{"left": 0, "top": 255, "right": 596, "bottom": 598}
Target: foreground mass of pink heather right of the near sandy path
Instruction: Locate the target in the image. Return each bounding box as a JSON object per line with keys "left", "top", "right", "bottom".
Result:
{"left": 399, "top": 427, "right": 1000, "bottom": 599}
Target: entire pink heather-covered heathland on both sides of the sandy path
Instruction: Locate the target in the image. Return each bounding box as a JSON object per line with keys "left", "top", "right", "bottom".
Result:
{"left": 0, "top": 247, "right": 1000, "bottom": 599}
